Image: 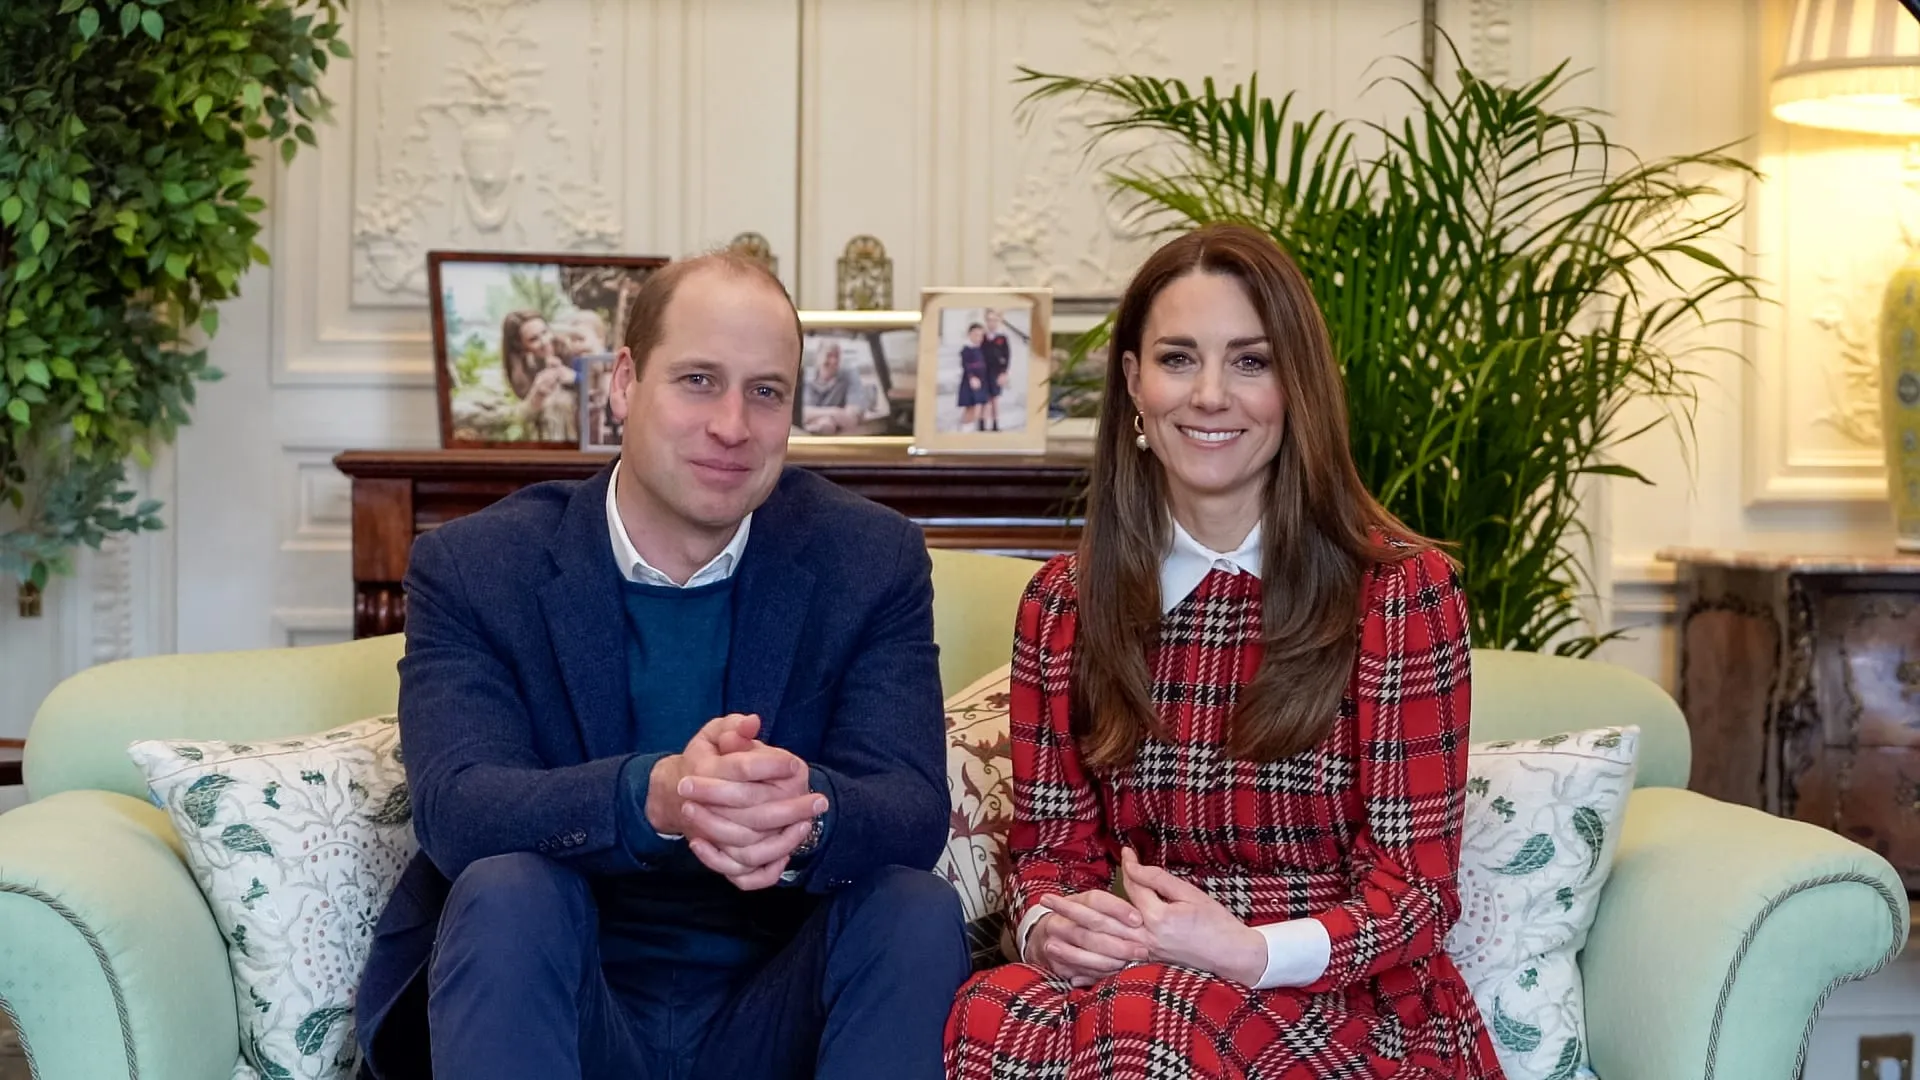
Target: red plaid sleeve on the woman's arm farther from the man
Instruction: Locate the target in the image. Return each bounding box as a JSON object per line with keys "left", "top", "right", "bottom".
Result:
{"left": 1306, "top": 552, "right": 1471, "bottom": 992}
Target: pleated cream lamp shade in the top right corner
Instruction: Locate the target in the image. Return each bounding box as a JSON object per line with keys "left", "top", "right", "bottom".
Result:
{"left": 1772, "top": 0, "right": 1920, "bottom": 135}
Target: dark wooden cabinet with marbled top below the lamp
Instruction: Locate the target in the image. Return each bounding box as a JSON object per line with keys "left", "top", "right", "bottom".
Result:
{"left": 1661, "top": 550, "right": 1920, "bottom": 890}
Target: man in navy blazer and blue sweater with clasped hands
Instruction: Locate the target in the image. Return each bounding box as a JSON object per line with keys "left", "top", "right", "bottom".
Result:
{"left": 359, "top": 254, "right": 968, "bottom": 1080}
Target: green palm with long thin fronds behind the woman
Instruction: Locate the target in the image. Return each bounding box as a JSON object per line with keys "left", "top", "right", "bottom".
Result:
{"left": 1021, "top": 58, "right": 1757, "bottom": 655}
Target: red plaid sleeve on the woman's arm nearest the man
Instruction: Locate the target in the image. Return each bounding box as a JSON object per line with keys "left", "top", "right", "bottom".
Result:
{"left": 1008, "top": 555, "right": 1114, "bottom": 922}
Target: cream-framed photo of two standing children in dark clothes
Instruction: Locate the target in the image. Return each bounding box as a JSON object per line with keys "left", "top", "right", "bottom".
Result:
{"left": 912, "top": 288, "right": 1052, "bottom": 454}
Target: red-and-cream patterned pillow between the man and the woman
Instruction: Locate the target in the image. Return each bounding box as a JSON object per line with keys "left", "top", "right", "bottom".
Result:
{"left": 933, "top": 665, "right": 1014, "bottom": 969}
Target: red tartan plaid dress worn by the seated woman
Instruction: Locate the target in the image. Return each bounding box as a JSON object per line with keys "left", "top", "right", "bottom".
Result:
{"left": 947, "top": 552, "right": 1501, "bottom": 1080}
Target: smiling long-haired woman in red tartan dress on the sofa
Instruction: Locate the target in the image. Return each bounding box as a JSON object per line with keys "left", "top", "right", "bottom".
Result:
{"left": 947, "top": 227, "right": 1500, "bottom": 1080}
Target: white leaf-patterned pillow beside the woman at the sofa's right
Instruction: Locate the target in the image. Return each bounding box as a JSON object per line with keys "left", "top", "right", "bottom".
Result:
{"left": 1446, "top": 726, "right": 1640, "bottom": 1080}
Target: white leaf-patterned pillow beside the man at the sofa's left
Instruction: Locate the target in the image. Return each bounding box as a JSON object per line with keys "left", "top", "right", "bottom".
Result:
{"left": 129, "top": 717, "right": 417, "bottom": 1080}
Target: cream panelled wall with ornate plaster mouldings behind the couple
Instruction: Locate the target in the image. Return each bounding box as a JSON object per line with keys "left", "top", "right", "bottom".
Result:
{"left": 0, "top": 0, "right": 1889, "bottom": 722}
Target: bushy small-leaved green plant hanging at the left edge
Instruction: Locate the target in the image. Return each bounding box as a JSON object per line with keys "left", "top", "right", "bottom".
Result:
{"left": 0, "top": 0, "right": 349, "bottom": 594}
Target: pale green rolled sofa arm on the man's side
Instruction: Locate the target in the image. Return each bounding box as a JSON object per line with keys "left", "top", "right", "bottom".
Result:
{"left": 0, "top": 790, "right": 240, "bottom": 1080}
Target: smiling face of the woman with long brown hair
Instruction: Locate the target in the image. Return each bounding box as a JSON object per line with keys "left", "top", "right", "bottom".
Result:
{"left": 1121, "top": 271, "right": 1286, "bottom": 528}
